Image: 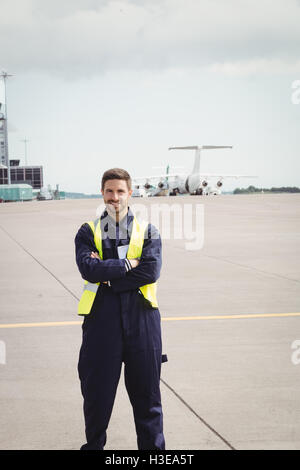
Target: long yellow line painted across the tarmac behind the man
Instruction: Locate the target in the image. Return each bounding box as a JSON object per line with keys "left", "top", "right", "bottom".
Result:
{"left": 0, "top": 312, "right": 300, "bottom": 329}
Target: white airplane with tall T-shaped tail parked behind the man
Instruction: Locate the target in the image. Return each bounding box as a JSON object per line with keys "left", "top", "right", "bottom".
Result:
{"left": 135, "top": 145, "right": 256, "bottom": 196}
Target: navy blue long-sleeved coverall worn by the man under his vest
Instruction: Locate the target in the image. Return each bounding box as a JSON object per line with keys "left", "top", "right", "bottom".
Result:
{"left": 75, "top": 208, "right": 167, "bottom": 450}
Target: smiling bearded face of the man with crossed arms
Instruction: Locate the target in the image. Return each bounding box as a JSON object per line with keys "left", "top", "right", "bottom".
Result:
{"left": 101, "top": 179, "right": 132, "bottom": 217}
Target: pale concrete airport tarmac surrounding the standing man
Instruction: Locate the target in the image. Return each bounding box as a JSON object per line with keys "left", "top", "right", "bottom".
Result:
{"left": 0, "top": 194, "right": 300, "bottom": 450}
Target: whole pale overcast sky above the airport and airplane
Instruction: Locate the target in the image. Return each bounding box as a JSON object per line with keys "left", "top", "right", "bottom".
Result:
{"left": 0, "top": 0, "right": 300, "bottom": 193}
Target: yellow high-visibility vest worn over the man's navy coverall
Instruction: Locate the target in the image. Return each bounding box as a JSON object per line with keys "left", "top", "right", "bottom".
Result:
{"left": 78, "top": 217, "right": 158, "bottom": 315}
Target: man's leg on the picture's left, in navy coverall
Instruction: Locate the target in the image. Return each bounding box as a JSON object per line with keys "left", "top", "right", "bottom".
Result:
{"left": 78, "top": 296, "right": 123, "bottom": 450}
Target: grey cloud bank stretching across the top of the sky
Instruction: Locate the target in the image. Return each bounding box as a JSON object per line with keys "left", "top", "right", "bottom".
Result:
{"left": 0, "top": 0, "right": 300, "bottom": 77}
